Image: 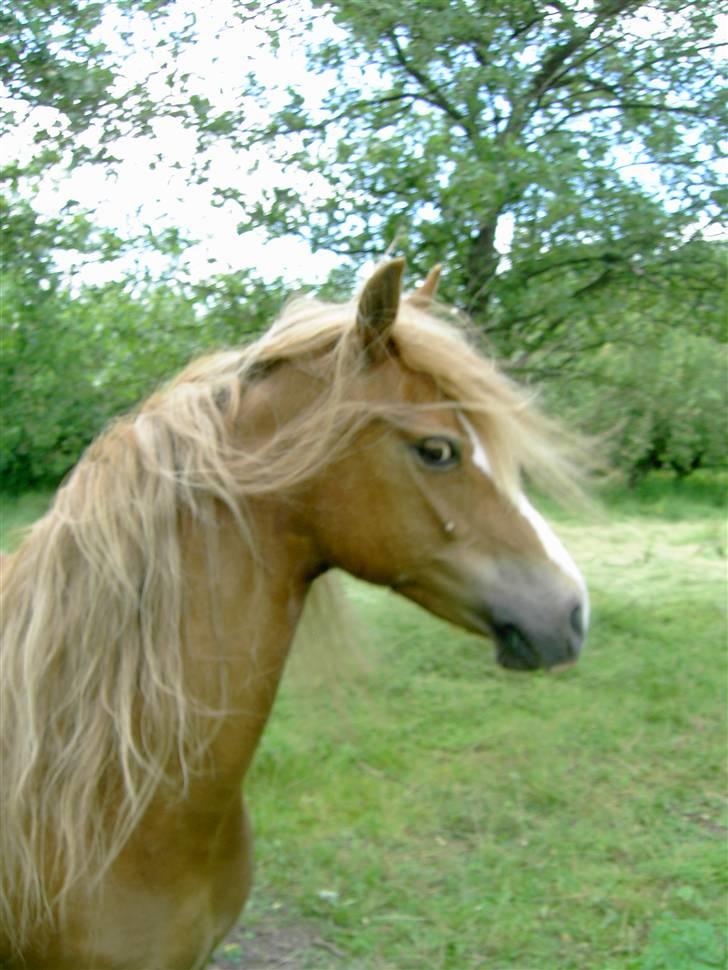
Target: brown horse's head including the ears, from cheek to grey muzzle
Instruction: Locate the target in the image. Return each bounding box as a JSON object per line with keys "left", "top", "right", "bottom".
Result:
{"left": 312, "top": 261, "right": 588, "bottom": 670}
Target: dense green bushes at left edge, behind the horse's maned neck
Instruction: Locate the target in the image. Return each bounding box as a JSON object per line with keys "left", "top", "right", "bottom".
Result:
{"left": 0, "top": 273, "right": 283, "bottom": 490}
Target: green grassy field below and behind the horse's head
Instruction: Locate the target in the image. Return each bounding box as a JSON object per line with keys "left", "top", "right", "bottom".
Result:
{"left": 4, "top": 476, "right": 728, "bottom": 970}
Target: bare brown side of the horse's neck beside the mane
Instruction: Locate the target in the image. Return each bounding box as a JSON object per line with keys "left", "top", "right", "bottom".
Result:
{"left": 183, "top": 503, "right": 315, "bottom": 785}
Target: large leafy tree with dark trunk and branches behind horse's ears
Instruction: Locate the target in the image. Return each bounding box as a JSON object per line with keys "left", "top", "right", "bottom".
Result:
{"left": 232, "top": 0, "right": 726, "bottom": 366}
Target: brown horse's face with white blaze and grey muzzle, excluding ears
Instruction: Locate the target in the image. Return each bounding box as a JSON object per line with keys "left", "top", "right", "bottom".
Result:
{"left": 317, "top": 362, "right": 588, "bottom": 669}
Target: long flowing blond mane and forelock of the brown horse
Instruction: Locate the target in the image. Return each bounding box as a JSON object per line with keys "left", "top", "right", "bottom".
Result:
{"left": 0, "top": 288, "right": 571, "bottom": 940}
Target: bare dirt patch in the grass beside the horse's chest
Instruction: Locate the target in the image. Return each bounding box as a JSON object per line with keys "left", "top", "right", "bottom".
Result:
{"left": 208, "top": 915, "right": 345, "bottom": 970}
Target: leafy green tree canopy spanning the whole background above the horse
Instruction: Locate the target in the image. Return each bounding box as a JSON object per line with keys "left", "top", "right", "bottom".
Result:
{"left": 0, "top": 0, "right": 728, "bottom": 480}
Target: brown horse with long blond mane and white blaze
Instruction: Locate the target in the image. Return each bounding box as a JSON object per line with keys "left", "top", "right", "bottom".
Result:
{"left": 0, "top": 260, "right": 588, "bottom": 970}
